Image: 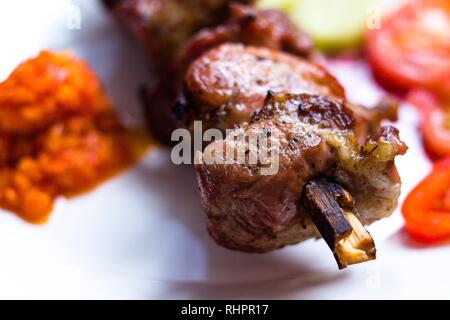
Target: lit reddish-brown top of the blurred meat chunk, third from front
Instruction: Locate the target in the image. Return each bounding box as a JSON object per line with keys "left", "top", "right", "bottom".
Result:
{"left": 181, "top": 3, "right": 313, "bottom": 66}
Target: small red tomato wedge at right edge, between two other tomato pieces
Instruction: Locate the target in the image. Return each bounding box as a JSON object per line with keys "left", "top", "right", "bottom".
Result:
{"left": 408, "top": 90, "right": 450, "bottom": 158}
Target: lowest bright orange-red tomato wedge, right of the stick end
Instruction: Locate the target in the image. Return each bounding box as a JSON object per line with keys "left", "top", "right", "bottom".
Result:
{"left": 402, "top": 158, "right": 450, "bottom": 243}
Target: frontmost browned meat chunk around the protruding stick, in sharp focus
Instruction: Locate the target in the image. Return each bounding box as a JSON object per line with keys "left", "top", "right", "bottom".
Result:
{"left": 196, "top": 94, "right": 406, "bottom": 252}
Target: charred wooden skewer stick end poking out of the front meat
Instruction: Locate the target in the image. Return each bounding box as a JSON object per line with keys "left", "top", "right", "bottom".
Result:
{"left": 302, "top": 178, "right": 376, "bottom": 269}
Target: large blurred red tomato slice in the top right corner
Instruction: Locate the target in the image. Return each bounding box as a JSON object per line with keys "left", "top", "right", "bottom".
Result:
{"left": 366, "top": 0, "right": 450, "bottom": 97}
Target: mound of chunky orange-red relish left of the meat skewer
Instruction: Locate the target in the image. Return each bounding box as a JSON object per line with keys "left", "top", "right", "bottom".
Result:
{"left": 0, "top": 51, "right": 145, "bottom": 223}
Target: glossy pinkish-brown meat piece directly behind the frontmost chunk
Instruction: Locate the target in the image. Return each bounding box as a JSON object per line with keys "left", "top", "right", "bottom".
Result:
{"left": 180, "top": 44, "right": 345, "bottom": 130}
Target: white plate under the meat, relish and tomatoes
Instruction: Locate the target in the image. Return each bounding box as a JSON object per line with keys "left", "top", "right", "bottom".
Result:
{"left": 0, "top": 0, "right": 450, "bottom": 299}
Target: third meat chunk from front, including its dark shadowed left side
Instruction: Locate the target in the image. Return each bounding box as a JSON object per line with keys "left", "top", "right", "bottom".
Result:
{"left": 142, "top": 3, "right": 314, "bottom": 141}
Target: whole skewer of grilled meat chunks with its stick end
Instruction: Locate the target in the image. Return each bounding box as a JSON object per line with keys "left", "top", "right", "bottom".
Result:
{"left": 105, "top": 0, "right": 406, "bottom": 268}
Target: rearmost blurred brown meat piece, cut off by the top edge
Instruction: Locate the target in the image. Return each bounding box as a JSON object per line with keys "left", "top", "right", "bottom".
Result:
{"left": 102, "top": 0, "right": 254, "bottom": 72}
